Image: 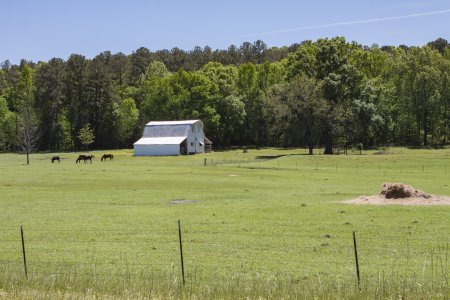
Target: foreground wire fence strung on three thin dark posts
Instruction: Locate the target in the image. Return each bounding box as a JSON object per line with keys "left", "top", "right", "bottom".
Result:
{"left": 0, "top": 222, "right": 450, "bottom": 285}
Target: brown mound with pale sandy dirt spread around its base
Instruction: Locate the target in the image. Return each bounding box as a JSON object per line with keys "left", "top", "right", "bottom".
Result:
{"left": 344, "top": 183, "right": 450, "bottom": 205}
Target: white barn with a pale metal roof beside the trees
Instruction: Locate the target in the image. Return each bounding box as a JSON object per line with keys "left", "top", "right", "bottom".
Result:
{"left": 134, "top": 120, "right": 205, "bottom": 156}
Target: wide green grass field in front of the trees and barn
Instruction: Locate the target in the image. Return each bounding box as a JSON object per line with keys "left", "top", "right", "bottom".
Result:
{"left": 0, "top": 148, "right": 450, "bottom": 299}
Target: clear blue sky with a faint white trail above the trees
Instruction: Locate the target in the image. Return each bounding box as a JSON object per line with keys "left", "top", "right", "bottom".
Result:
{"left": 0, "top": 0, "right": 450, "bottom": 63}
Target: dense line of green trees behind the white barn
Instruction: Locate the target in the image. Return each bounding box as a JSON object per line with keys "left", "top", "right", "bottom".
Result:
{"left": 0, "top": 37, "right": 450, "bottom": 154}
